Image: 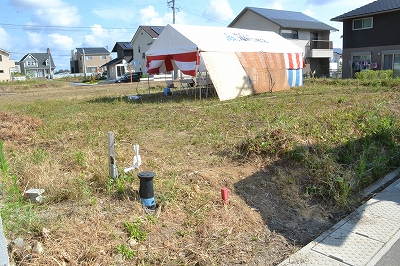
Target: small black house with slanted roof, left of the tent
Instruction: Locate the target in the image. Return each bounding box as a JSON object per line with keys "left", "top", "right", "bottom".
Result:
{"left": 102, "top": 42, "right": 134, "bottom": 79}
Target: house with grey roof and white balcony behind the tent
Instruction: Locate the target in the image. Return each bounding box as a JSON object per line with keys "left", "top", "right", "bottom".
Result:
{"left": 228, "top": 7, "right": 338, "bottom": 76}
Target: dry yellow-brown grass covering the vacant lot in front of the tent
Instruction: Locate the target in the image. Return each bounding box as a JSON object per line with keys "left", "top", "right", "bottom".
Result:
{"left": 0, "top": 82, "right": 397, "bottom": 265}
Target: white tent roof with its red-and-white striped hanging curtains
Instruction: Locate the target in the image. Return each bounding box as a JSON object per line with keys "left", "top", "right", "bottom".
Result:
{"left": 146, "top": 24, "right": 303, "bottom": 76}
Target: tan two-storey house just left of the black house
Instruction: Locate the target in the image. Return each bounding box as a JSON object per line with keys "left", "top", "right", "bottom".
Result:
{"left": 70, "top": 47, "right": 110, "bottom": 75}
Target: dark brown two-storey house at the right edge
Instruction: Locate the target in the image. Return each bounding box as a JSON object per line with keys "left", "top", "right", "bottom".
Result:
{"left": 331, "top": 0, "right": 400, "bottom": 78}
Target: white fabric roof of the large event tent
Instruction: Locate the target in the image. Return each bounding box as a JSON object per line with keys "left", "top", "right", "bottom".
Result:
{"left": 146, "top": 24, "right": 302, "bottom": 56}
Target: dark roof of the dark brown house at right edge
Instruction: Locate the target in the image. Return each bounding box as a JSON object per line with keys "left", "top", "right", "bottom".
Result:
{"left": 331, "top": 0, "right": 400, "bottom": 21}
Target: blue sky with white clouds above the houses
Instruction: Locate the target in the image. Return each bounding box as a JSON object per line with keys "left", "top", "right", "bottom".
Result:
{"left": 0, "top": 0, "right": 373, "bottom": 70}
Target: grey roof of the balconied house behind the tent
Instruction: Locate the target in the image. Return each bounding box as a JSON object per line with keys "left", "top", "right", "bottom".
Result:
{"left": 228, "top": 7, "right": 338, "bottom": 31}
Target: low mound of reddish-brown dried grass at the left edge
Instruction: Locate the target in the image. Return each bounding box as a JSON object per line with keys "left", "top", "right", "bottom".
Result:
{"left": 0, "top": 112, "right": 42, "bottom": 142}
